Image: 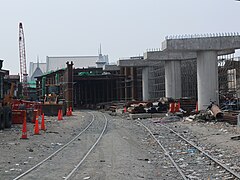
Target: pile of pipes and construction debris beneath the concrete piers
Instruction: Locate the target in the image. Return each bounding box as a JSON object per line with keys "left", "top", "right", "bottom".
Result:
{"left": 96, "top": 98, "right": 240, "bottom": 125}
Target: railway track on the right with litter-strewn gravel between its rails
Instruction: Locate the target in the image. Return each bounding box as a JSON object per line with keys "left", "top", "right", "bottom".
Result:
{"left": 136, "top": 120, "right": 240, "bottom": 180}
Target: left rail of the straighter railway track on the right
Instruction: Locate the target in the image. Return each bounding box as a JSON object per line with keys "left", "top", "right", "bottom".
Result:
{"left": 135, "top": 120, "right": 188, "bottom": 180}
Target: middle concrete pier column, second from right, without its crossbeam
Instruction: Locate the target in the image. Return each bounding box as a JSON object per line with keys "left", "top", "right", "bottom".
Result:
{"left": 165, "top": 60, "right": 182, "bottom": 99}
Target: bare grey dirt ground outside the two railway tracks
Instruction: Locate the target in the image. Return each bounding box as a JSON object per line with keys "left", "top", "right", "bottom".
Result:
{"left": 0, "top": 110, "right": 240, "bottom": 180}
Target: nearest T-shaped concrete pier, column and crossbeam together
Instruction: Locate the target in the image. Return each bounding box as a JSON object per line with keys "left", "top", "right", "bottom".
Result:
{"left": 162, "top": 36, "right": 240, "bottom": 110}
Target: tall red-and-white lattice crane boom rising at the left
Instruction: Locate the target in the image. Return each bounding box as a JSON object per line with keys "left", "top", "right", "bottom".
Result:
{"left": 19, "top": 22, "right": 28, "bottom": 98}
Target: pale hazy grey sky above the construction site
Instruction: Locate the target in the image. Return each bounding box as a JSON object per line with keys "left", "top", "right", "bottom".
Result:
{"left": 0, "top": 0, "right": 240, "bottom": 74}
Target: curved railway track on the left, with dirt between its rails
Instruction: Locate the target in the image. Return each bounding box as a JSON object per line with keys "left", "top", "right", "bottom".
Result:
{"left": 14, "top": 112, "right": 108, "bottom": 180}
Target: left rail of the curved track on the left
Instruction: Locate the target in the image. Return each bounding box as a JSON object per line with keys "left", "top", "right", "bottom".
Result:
{"left": 13, "top": 112, "right": 95, "bottom": 180}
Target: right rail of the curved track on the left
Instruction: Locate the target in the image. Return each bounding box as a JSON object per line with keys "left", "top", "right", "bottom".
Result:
{"left": 64, "top": 114, "right": 108, "bottom": 180}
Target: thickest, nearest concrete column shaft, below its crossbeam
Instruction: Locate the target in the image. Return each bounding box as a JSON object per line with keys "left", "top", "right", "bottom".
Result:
{"left": 197, "top": 51, "right": 219, "bottom": 110}
